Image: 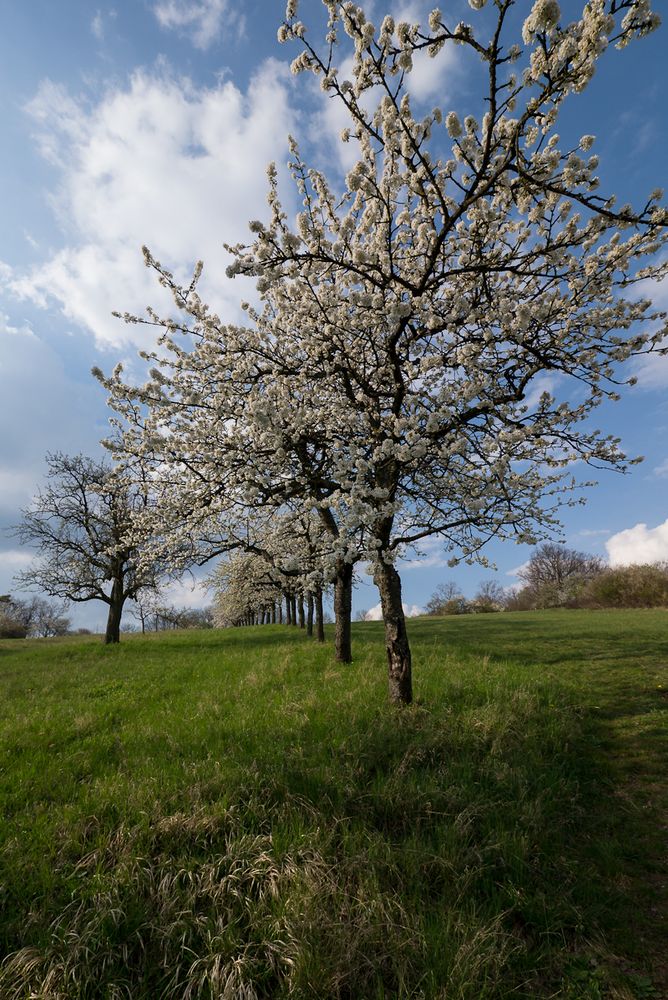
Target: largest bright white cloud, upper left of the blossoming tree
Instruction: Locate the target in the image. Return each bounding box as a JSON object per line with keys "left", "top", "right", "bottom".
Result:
{"left": 11, "top": 60, "right": 292, "bottom": 346}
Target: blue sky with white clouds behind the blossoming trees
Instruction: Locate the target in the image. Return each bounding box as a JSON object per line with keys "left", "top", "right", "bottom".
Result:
{"left": 0, "top": 0, "right": 668, "bottom": 625}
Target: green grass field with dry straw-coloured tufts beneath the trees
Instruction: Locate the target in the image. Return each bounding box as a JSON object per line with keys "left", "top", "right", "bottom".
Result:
{"left": 0, "top": 611, "right": 668, "bottom": 1000}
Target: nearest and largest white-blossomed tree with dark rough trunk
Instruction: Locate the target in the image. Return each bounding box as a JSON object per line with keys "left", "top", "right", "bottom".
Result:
{"left": 98, "top": 0, "right": 666, "bottom": 703}
